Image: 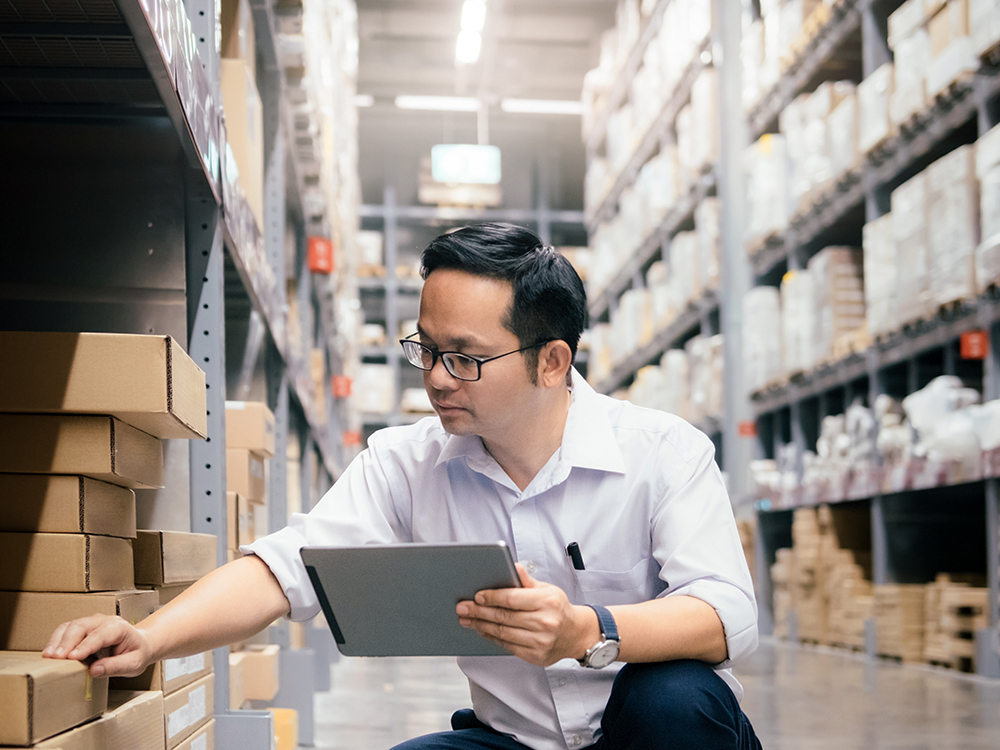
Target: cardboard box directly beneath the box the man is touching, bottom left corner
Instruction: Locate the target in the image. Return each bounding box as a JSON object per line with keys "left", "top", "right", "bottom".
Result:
{"left": 35, "top": 690, "right": 164, "bottom": 750}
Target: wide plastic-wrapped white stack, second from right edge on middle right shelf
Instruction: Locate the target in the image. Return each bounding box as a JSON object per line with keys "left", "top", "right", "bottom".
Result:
{"left": 927, "top": 146, "right": 979, "bottom": 308}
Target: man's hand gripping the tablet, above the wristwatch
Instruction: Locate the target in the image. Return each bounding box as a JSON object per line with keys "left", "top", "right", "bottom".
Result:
{"left": 456, "top": 563, "right": 600, "bottom": 667}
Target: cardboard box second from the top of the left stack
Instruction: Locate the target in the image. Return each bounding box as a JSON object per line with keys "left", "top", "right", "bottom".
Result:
{"left": 0, "top": 414, "right": 163, "bottom": 489}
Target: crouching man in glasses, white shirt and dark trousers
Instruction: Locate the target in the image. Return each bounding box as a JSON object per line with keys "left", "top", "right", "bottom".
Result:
{"left": 39, "top": 224, "right": 759, "bottom": 750}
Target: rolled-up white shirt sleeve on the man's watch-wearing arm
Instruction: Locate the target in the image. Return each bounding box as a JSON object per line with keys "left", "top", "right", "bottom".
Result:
{"left": 653, "top": 438, "right": 758, "bottom": 668}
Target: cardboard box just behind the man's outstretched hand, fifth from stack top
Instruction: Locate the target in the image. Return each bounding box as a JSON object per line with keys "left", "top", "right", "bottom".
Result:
{"left": 0, "top": 589, "right": 159, "bottom": 651}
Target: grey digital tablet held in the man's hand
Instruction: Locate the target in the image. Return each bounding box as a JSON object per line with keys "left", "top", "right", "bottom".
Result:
{"left": 302, "top": 542, "right": 521, "bottom": 656}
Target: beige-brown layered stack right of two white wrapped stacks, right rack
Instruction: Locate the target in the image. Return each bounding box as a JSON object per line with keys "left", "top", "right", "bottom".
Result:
{"left": 808, "top": 247, "right": 865, "bottom": 363}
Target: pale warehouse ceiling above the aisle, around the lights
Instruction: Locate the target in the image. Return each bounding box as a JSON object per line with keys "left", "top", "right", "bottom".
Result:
{"left": 357, "top": 0, "right": 617, "bottom": 220}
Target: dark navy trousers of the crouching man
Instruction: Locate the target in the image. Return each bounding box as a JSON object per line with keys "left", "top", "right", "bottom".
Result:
{"left": 395, "top": 661, "right": 760, "bottom": 750}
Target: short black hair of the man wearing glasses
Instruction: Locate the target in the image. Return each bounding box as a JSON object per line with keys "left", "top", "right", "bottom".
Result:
{"left": 420, "top": 223, "right": 587, "bottom": 383}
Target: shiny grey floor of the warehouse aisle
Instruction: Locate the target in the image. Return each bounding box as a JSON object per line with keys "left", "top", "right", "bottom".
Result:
{"left": 315, "top": 639, "right": 1000, "bottom": 750}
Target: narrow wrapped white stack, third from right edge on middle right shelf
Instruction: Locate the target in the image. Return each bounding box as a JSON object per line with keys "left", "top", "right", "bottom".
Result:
{"left": 890, "top": 172, "right": 931, "bottom": 325}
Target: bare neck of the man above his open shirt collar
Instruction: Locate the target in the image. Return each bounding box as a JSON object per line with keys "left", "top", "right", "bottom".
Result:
{"left": 482, "top": 390, "right": 572, "bottom": 492}
